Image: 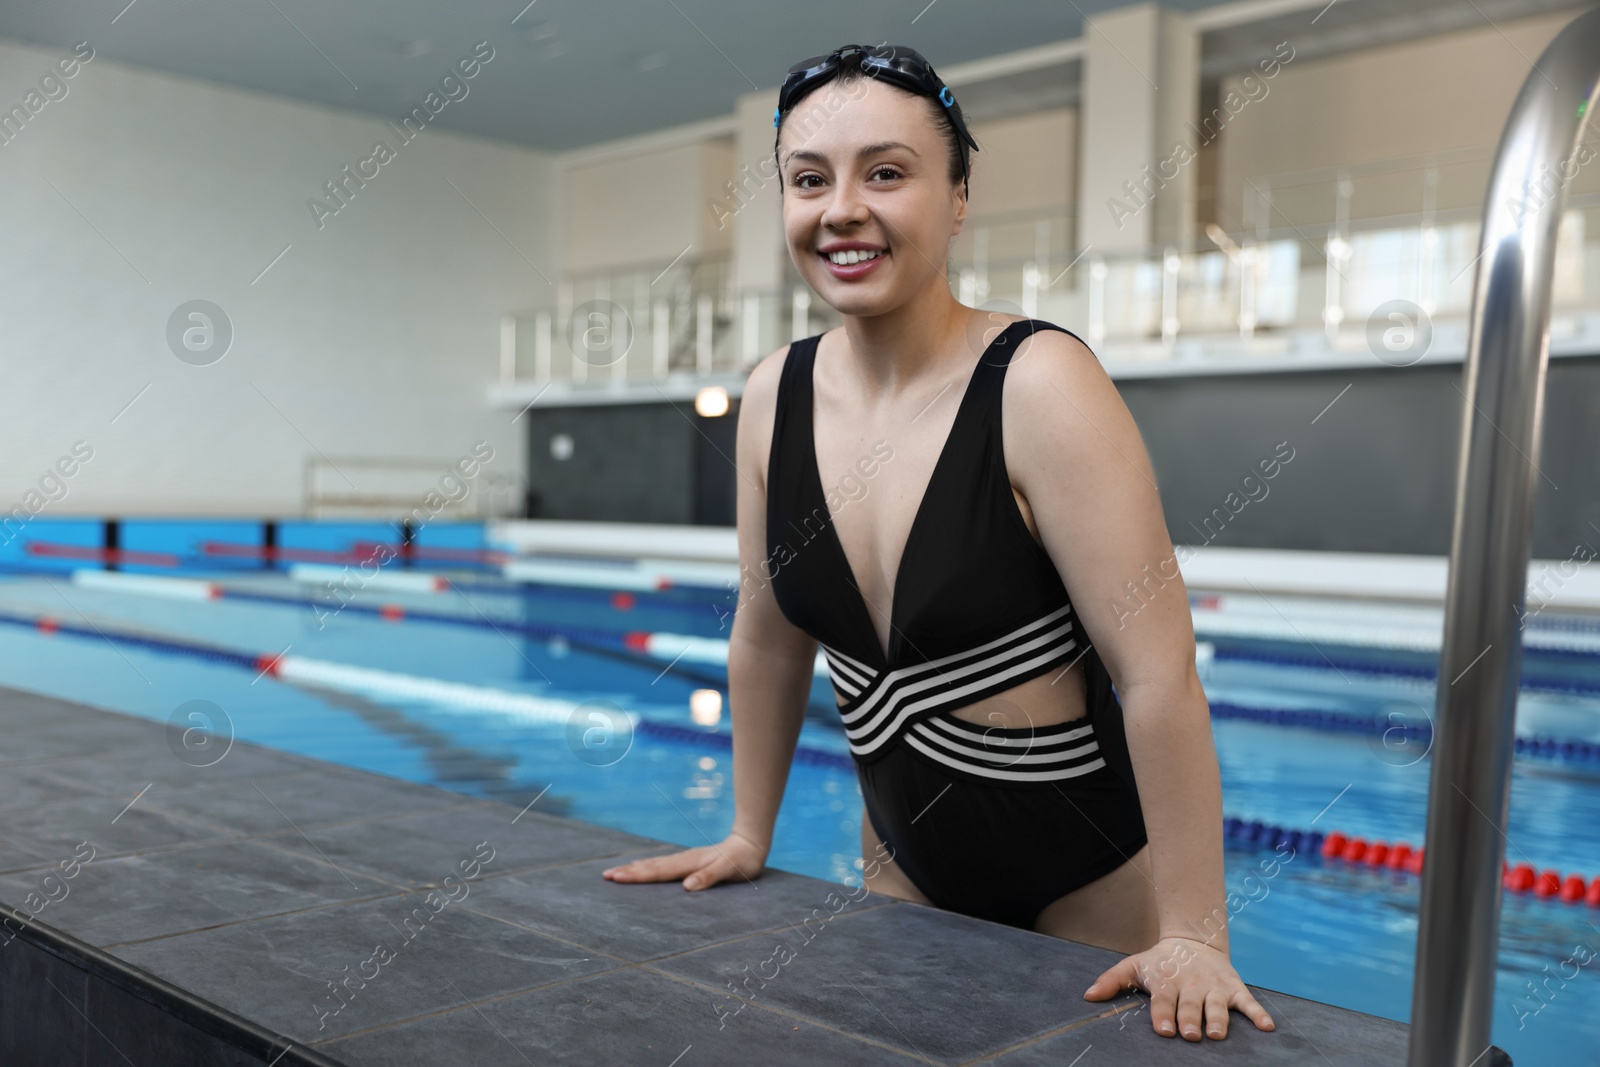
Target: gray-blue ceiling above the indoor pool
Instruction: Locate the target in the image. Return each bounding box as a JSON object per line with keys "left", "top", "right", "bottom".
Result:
{"left": 0, "top": 0, "right": 1571, "bottom": 150}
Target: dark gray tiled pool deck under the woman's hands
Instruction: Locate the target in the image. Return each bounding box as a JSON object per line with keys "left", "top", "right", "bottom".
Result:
{"left": 0, "top": 688, "right": 1405, "bottom": 1067}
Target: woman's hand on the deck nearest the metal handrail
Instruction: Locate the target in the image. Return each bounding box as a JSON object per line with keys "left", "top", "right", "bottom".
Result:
{"left": 1083, "top": 937, "right": 1275, "bottom": 1041}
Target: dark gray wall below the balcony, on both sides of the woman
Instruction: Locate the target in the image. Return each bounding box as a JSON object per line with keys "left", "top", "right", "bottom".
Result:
{"left": 525, "top": 357, "right": 1600, "bottom": 558}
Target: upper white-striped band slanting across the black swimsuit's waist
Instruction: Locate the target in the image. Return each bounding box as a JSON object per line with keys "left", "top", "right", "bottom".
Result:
{"left": 824, "top": 605, "right": 1077, "bottom": 757}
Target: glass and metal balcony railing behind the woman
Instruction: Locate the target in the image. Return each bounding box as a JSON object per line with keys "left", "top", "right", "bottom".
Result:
{"left": 502, "top": 194, "right": 1600, "bottom": 387}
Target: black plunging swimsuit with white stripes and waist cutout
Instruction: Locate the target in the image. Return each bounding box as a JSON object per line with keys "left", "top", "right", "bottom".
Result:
{"left": 766, "top": 320, "right": 1146, "bottom": 926}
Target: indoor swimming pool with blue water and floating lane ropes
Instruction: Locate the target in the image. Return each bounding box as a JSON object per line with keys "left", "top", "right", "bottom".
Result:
{"left": 0, "top": 525, "right": 1600, "bottom": 1064}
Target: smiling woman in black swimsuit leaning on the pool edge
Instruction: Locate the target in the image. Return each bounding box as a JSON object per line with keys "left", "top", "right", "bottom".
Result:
{"left": 605, "top": 45, "right": 1274, "bottom": 1041}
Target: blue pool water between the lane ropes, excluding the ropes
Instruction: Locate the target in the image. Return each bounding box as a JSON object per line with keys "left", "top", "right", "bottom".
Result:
{"left": 0, "top": 531, "right": 1600, "bottom": 1064}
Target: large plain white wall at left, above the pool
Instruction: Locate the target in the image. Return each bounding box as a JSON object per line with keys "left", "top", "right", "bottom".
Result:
{"left": 0, "top": 42, "right": 563, "bottom": 515}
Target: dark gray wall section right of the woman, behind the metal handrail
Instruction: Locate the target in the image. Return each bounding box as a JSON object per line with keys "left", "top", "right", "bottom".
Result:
{"left": 1118, "top": 358, "right": 1600, "bottom": 558}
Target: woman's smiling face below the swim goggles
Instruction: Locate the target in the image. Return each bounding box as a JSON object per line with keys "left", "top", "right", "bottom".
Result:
{"left": 778, "top": 78, "right": 966, "bottom": 317}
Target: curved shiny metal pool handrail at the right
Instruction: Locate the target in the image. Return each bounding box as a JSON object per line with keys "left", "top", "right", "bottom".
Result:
{"left": 1406, "top": 10, "right": 1600, "bottom": 1067}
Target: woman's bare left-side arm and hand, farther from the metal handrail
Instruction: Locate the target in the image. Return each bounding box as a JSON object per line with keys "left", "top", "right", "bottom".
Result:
{"left": 605, "top": 349, "right": 816, "bottom": 889}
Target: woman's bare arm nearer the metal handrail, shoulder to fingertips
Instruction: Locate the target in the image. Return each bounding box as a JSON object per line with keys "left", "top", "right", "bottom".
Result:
{"left": 1005, "top": 331, "right": 1270, "bottom": 1038}
